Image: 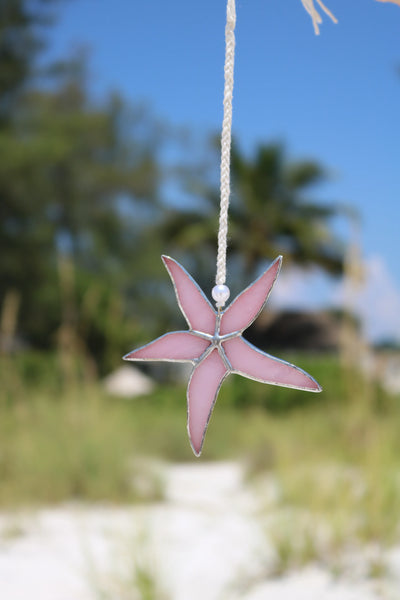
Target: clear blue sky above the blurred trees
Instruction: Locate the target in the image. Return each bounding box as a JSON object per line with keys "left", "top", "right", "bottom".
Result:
{"left": 49, "top": 0, "right": 400, "bottom": 337}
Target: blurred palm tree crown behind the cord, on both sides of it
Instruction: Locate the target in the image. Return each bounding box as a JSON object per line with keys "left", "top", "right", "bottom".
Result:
{"left": 160, "top": 145, "right": 343, "bottom": 288}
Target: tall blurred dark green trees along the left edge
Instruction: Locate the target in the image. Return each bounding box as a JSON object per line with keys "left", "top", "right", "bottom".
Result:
{"left": 0, "top": 0, "right": 166, "bottom": 370}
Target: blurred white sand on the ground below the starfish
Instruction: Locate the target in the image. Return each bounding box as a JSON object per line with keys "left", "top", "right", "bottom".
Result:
{"left": 0, "top": 463, "right": 400, "bottom": 600}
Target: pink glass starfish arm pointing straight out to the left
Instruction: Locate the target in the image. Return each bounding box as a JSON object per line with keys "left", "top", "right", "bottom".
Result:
{"left": 124, "top": 331, "right": 210, "bottom": 362}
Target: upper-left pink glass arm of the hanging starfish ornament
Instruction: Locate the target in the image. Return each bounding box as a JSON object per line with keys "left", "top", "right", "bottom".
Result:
{"left": 162, "top": 256, "right": 216, "bottom": 335}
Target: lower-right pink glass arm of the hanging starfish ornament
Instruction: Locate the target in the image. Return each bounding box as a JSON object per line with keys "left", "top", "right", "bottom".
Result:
{"left": 224, "top": 337, "right": 322, "bottom": 392}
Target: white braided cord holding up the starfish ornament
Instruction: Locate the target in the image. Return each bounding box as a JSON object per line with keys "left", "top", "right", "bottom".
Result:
{"left": 215, "top": 0, "right": 236, "bottom": 286}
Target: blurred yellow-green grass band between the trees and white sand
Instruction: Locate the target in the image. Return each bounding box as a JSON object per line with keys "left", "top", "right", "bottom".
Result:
{"left": 0, "top": 354, "right": 400, "bottom": 532}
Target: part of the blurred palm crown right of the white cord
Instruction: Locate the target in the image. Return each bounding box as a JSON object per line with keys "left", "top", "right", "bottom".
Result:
{"left": 230, "top": 145, "right": 343, "bottom": 274}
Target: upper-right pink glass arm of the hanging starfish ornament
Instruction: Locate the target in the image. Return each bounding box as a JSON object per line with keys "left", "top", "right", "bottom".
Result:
{"left": 220, "top": 256, "right": 282, "bottom": 335}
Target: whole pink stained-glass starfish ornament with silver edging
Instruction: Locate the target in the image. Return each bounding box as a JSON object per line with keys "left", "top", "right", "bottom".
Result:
{"left": 124, "top": 256, "right": 321, "bottom": 456}
